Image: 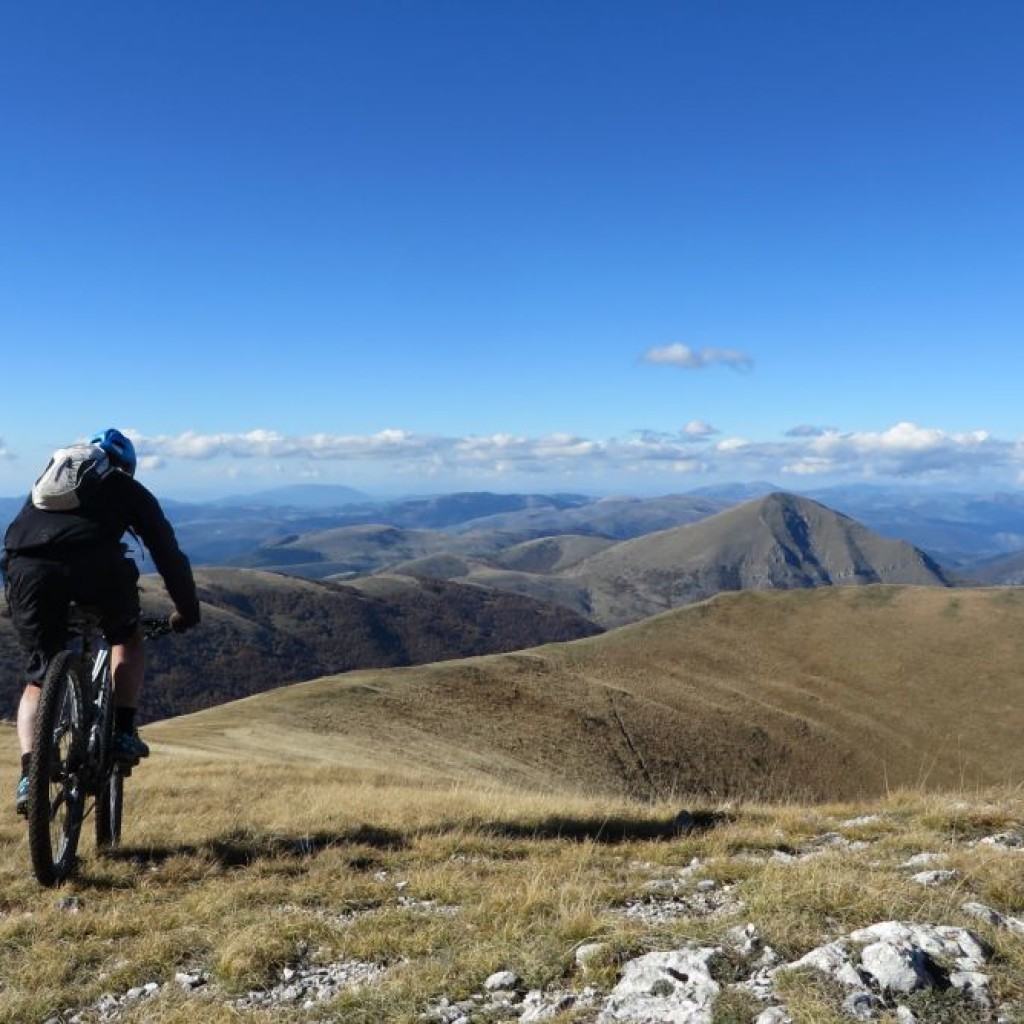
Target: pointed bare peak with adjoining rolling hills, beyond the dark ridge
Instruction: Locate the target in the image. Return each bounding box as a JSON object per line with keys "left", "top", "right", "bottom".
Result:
{"left": 232, "top": 494, "right": 952, "bottom": 627}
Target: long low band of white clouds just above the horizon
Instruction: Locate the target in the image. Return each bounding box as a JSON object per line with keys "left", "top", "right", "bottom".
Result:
{"left": 14, "top": 420, "right": 1007, "bottom": 489}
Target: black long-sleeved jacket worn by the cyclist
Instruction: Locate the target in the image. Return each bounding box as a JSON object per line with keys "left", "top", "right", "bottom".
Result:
{"left": 4, "top": 472, "right": 199, "bottom": 622}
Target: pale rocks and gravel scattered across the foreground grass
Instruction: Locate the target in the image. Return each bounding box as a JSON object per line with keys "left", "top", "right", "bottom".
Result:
{"left": 48, "top": 817, "right": 1024, "bottom": 1024}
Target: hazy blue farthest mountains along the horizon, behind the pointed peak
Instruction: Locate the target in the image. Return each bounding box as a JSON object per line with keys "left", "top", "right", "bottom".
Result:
{"left": 6, "top": 482, "right": 1024, "bottom": 580}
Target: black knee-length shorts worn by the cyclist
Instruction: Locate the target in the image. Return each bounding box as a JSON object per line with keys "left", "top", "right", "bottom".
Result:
{"left": 5, "top": 550, "right": 141, "bottom": 683}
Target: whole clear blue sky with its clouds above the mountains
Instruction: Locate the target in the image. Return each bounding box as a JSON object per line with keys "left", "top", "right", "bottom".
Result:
{"left": 0, "top": 0, "right": 1024, "bottom": 497}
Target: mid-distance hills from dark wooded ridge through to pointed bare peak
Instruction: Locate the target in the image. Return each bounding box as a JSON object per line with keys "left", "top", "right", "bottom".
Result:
{"left": 0, "top": 494, "right": 953, "bottom": 718}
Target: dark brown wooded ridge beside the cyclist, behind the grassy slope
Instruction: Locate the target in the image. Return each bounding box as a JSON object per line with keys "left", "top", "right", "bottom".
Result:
{"left": 0, "top": 568, "right": 600, "bottom": 721}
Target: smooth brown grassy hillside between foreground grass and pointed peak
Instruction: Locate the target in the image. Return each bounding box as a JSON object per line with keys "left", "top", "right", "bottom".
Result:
{"left": 150, "top": 586, "right": 1024, "bottom": 799}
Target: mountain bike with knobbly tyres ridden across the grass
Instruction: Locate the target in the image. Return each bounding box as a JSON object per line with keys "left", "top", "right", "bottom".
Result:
{"left": 27, "top": 605, "right": 171, "bottom": 886}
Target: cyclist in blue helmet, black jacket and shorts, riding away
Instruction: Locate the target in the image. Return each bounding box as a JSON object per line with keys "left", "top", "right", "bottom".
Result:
{"left": 0, "top": 427, "right": 200, "bottom": 814}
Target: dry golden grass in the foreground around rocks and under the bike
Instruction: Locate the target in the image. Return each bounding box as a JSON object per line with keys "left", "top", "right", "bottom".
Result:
{"left": 0, "top": 729, "right": 1024, "bottom": 1024}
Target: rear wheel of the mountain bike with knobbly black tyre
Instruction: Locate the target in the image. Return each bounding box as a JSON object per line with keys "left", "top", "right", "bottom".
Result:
{"left": 28, "top": 651, "right": 88, "bottom": 886}
